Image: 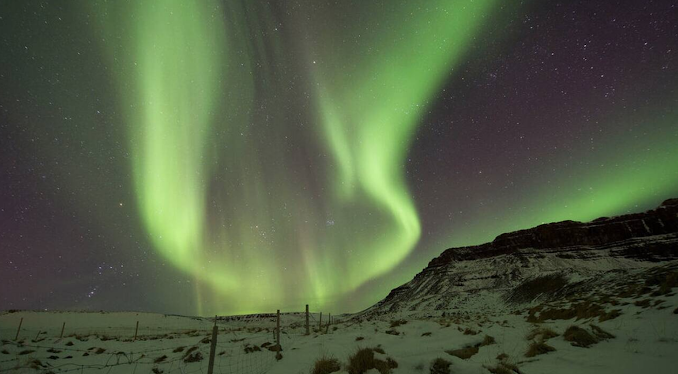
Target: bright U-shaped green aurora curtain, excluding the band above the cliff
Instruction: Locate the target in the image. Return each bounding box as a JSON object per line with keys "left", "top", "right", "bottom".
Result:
{"left": 94, "top": 0, "right": 500, "bottom": 314}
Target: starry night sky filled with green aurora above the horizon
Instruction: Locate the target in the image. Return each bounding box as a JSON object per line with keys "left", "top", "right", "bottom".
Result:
{"left": 0, "top": 0, "right": 678, "bottom": 315}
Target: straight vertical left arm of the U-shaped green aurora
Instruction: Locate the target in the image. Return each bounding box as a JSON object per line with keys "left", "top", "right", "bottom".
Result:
{"left": 130, "top": 0, "right": 225, "bottom": 271}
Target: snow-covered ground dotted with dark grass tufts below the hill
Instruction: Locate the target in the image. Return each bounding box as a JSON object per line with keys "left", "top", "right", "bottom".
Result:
{"left": 0, "top": 264, "right": 678, "bottom": 374}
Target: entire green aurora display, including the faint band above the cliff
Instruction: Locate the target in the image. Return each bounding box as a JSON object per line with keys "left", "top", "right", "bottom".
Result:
{"left": 0, "top": 0, "right": 678, "bottom": 315}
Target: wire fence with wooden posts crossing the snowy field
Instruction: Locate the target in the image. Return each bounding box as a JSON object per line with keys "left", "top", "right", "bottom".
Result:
{"left": 0, "top": 313, "right": 330, "bottom": 374}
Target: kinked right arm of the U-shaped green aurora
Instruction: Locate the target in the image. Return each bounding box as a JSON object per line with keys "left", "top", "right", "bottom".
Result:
{"left": 315, "top": 1, "right": 494, "bottom": 295}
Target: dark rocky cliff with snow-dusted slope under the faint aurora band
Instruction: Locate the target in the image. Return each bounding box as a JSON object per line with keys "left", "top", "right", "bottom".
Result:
{"left": 361, "top": 199, "right": 678, "bottom": 314}
